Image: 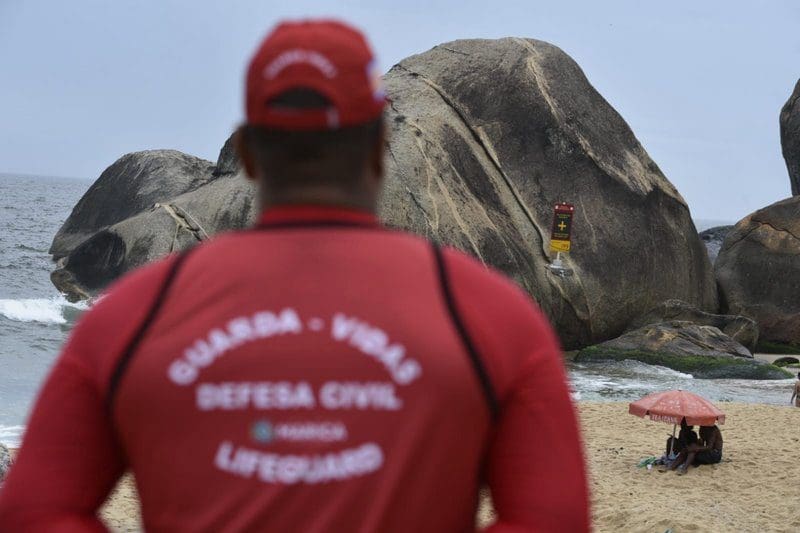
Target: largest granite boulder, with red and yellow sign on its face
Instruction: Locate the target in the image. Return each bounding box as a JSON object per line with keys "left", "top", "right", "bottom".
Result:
{"left": 382, "top": 38, "right": 717, "bottom": 349}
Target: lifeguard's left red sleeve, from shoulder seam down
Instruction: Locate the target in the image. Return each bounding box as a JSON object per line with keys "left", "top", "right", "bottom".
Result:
{"left": 0, "top": 256, "right": 181, "bottom": 532}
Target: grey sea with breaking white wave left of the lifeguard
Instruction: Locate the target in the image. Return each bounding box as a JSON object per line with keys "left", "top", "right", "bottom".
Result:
{"left": 0, "top": 174, "right": 92, "bottom": 445}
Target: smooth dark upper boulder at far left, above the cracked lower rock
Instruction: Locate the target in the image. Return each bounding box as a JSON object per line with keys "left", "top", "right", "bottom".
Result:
{"left": 50, "top": 150, "right": 214, "bottom": 259}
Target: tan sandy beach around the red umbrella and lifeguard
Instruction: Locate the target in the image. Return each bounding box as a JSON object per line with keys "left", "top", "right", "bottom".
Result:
{"left": 32, "top": 404, "right": 800, "bottom": 533}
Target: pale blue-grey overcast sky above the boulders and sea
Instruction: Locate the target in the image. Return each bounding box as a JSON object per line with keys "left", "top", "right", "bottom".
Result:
{"left": 0, "top": 0, "right": 800, "bottom": 221}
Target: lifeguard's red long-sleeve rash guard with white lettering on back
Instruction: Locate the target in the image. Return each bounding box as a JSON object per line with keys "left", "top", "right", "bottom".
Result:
{"left": 0, "top": 208, "right": 589, "bottom": 532}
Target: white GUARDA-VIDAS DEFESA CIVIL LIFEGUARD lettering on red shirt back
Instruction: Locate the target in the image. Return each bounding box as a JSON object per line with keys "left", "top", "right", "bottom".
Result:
{"left": 172, "top": 308, "right": 422, "bottom": 485}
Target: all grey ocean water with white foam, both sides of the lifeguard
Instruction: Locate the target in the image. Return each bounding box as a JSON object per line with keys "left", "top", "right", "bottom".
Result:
{"left": 0, "top": 174, "right": 793, "bottom": 446}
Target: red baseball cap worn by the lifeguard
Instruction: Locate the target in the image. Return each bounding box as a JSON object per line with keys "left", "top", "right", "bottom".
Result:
{"left": 245, "top": 20, "right": 386, "bottom": 130}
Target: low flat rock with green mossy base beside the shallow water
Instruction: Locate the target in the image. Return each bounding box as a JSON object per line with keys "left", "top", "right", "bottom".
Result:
{"left": 574, "top": 321, "right": 791, "bottom": 379}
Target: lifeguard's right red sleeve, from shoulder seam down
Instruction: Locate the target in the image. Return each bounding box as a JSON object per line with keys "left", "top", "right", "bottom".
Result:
{"left": 445, "top": 250, "right": 589, "bottom": 533}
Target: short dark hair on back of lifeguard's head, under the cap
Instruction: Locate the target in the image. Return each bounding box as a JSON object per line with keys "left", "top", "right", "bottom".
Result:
{"left": 241, "top": 89, "right": 382, "bottom": 189}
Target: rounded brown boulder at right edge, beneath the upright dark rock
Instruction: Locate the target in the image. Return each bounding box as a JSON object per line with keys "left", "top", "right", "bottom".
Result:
{"left": 715, "top": 196, "right": 800, "bottom": 344}
